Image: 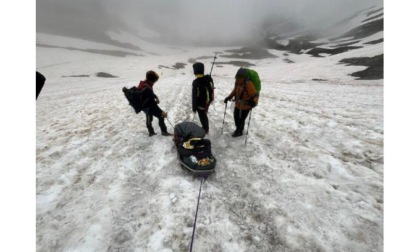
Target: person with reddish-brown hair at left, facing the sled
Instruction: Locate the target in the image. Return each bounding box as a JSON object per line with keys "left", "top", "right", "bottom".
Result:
{"left": 137, "top": 71, "right": 172, "bottom": 136}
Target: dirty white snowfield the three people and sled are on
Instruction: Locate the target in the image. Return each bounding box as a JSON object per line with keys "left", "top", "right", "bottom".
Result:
{"left": 36, "top": 33, "right": 383, "bottom": 251}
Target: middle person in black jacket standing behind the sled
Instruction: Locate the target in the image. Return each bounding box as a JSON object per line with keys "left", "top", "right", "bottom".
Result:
{"left": 192, "top": 62, "right": 214, "bottom": 134}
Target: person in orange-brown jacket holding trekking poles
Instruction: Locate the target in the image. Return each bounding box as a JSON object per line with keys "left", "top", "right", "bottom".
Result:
{"left": 225, "top": 68, "right": 258, "bottom": 137}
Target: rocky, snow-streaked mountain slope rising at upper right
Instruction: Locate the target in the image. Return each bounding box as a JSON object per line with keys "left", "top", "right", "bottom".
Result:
{"left": 264, "top": 6, "right": 384, "bottom": 79}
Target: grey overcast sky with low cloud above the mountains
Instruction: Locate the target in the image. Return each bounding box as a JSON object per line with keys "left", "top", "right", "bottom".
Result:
{"left": 37, "top": 0, "right": 383, "bottom": 46}
